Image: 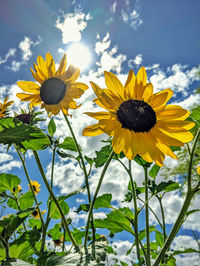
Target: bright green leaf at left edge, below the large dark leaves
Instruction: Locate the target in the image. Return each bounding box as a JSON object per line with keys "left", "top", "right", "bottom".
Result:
{"left": 0, "top": 174, "right": 21, "bottom": 192}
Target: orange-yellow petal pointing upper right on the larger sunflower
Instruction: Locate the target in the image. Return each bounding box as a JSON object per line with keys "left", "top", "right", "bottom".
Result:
{"left": 149, "top": 89, "right": 173, "bottom": 110}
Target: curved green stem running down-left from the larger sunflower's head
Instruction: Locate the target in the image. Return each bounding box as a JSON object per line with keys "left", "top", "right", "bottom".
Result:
{"left": 84, "top": 151, "right": 115, "bottom": 249}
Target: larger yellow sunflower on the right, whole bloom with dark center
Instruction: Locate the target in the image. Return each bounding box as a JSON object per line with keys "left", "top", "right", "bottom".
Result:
{"left": 83, "top": 67, "right": 195, "bottom": 166}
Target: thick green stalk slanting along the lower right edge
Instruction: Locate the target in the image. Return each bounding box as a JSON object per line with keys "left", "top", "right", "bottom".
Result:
{"left": 153, "top": 129, "right": 200, "bottom": 266}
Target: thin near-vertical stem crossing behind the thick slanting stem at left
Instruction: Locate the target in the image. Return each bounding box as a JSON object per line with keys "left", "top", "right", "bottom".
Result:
{"left": 40, "top": 145, "right": 56, "bottom": 252}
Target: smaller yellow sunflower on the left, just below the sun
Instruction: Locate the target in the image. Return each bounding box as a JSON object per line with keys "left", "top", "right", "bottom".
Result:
{"left": 17, "top": 52, "right": 88, "bottom": 115}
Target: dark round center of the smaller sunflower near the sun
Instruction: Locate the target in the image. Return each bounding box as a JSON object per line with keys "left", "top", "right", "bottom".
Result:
{"left": 40, "top": 78, "right": 66, "bottom": 105}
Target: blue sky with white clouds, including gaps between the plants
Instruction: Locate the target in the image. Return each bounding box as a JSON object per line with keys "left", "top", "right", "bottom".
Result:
{"left": 0, "top": 0, "right": 200, "bottom": 265}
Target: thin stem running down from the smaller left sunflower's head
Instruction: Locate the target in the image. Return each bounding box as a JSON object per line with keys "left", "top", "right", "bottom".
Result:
{"left": 63, "top": 113, "right": 96, "bottom": 240}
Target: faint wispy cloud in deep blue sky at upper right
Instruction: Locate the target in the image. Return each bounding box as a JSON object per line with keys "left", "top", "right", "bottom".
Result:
{"left": 121, "top": 9, "right": 143, "bottom": 30}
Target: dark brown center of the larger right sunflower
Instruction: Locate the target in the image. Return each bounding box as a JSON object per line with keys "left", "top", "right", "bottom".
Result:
{"left": 117, "top": 100, "right": 156, "bottom": 132}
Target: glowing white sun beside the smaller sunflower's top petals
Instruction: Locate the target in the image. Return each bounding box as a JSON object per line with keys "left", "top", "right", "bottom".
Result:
{"left": 66, "top": 43, "right": 91, "bottom": 71}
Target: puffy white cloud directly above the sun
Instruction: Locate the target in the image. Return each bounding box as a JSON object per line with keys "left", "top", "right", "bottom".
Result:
{"left": 56, "top": 12, "right": 92, "bottom": 44}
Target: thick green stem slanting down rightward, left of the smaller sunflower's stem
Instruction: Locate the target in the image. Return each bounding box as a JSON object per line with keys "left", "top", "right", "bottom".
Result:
{"left": 33, "top": 151, "right": 79, "bottom": 249}
